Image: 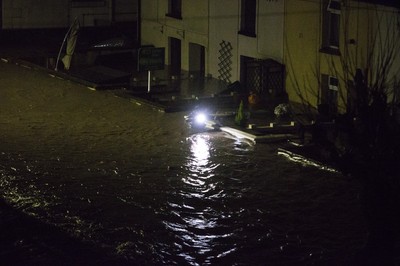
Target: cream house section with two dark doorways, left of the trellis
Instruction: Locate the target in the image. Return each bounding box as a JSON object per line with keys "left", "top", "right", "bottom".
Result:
{"left": 141, "top": 0, "right": 211, "bottom": 76}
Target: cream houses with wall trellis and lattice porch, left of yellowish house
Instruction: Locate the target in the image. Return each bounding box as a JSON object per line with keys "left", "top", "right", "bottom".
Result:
{"left": 141, "top": 0, "right": 285, "bottom": 104}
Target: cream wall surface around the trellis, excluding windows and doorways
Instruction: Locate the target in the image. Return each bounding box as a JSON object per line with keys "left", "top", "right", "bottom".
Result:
{"left": 141, "top": 0, "right": 284, "bottom": 82}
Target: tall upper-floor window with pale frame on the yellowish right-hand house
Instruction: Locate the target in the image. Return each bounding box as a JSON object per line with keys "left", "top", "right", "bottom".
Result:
{"left": 321, "top": 0, "right": 341, "bottom": 54}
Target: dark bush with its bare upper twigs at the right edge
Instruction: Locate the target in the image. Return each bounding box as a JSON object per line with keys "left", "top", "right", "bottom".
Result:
{"left": 286, "top": 7, "right": 400, "bottom": 265}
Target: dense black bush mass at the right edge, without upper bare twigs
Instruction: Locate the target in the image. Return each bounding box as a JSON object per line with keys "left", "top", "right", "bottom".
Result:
{"left": 319, "top": 72, "right": 400, "bottom": 265}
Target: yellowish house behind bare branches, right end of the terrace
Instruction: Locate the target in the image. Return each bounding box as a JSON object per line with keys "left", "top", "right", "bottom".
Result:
{"left": 284, "top": 0, "right": 400, "bottom": 113}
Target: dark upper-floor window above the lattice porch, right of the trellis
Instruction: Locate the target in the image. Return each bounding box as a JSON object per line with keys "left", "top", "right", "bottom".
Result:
{"left": 239, "top": 0, "right": 257, "bottom": 37}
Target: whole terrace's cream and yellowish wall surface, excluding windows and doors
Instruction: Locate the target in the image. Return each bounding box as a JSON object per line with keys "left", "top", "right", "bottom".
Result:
{"left": 142, "top": 0, "right": 400, "bottom": 108}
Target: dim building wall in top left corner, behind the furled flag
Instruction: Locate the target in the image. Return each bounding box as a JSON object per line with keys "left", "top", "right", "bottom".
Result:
{"left": 2, "top": 0, "right": 138, "bottom": 29}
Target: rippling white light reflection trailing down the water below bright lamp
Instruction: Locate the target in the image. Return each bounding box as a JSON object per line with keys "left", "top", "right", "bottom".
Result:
{"left": 165, "top": 134, "right": 234, "bottom": 265}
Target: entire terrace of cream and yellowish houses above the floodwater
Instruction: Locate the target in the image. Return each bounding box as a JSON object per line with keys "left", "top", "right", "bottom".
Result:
{"left": 141, "top": 0, "right": 399, "bottom": 112}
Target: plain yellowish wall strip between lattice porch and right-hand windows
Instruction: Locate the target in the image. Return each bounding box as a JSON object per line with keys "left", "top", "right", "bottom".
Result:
{"left": 284, "top": 0, "right": 320, "bottom": 108}
